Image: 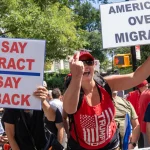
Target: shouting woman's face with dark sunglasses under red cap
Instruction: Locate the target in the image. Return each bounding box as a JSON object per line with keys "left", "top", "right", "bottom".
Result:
{"left": 80, "top": 56, "right": 94, "bottom": 81}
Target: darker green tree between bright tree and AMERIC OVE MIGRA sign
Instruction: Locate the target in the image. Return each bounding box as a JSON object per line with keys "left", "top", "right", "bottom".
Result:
{"left": 73, "top": 0, "right": 108, "bottom": 64}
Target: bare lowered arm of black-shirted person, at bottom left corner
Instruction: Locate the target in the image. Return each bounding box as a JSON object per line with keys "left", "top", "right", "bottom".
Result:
{"left": 4, "top": 123, "right": 20, "bottom": 150}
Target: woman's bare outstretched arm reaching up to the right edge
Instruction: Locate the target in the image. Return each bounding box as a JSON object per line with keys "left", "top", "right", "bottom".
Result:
{"left": 104, "top": 57, "right": 150, "bottom": 91}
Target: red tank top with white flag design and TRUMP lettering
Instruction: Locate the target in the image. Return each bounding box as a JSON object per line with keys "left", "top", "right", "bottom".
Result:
{"left": 70, "top": 86, "right": 116, "bottom": 149}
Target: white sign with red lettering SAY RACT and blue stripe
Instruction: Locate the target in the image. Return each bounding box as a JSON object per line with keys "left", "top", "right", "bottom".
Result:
{"left": 0, "top": 38, "right": 45, "bottom": 110}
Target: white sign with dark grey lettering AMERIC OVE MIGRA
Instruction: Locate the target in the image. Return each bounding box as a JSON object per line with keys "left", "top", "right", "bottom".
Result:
{"left": 100, "top": 0, "right": 150, "bottom": 48}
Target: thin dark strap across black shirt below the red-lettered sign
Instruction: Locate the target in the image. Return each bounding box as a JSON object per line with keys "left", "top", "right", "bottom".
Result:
{"left": 20, "top": 110, "right": 37, "bottom": 150}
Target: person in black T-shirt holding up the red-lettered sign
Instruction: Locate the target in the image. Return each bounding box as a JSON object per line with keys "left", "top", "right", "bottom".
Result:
{"left": 2, "top": 86, "right": 55, "bottom": 150}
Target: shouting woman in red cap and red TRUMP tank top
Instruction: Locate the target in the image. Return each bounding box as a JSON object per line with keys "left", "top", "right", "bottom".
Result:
{"left": 63, "top": 51, "right": 150, "bottom": 150}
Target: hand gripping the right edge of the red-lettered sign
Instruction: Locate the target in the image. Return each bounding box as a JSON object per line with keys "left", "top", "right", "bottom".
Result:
{"left": 33, "top": 86, "right": 48, "bottom": 101}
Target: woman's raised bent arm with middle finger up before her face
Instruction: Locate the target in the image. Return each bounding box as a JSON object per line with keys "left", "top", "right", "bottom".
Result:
{"left": 63, "top": 53, "right": 84, "bottom": 114}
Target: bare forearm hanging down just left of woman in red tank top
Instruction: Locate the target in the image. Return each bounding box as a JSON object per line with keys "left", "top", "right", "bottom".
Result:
{"left": 55, "top": 122, "right": 64, "bottom": 144}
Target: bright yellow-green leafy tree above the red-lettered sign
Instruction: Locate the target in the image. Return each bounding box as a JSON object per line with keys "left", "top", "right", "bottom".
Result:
{"left": 0, "top": 0, "right": 87, "bottom": 60}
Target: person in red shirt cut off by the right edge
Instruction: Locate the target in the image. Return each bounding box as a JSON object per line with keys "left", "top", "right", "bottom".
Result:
{"left": 139, "top": 89, "right": 150, "bottom": 148}
